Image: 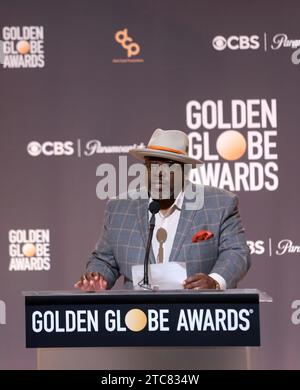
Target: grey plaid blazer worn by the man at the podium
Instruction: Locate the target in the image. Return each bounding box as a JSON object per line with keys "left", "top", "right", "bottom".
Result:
{"left": 87, "top": 186, "right": 250, "bottom": 288}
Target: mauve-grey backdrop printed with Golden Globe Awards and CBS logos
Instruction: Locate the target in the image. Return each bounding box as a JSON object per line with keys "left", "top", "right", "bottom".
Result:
{"left": 0, "top": 0, "right": 300, "bottom": 369}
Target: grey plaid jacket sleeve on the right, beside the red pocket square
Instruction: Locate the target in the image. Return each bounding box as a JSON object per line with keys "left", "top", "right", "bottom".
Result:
{"left": 211, "top": 195, "right": 251, "bottom": 288}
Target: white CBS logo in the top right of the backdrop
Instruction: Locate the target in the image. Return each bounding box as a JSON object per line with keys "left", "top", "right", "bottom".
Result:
{"left": 212, "top": 35, "right": 259, "bottom": 51}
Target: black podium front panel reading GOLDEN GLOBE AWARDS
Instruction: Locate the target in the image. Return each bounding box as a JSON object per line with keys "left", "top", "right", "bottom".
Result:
{"left": 25, "top": 290, "right": 260, "bottom": 348}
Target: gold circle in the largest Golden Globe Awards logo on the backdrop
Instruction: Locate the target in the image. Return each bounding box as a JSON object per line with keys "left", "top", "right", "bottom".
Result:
{"left": 217, "top": 130, "right": 247, "bottom": 161}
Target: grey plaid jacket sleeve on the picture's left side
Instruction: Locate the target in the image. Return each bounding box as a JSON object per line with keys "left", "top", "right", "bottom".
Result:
{"left": 86, "top": 201, "right": 120, "bottom": 289}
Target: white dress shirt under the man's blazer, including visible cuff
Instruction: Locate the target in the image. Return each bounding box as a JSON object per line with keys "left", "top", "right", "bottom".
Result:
{"left": 149, "top": 191, "right": 226, "bottom": 290}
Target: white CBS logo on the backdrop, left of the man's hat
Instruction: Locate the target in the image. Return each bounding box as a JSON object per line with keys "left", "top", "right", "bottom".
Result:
{"left": 27, "top": 141, "right": 74, "bottom": 157}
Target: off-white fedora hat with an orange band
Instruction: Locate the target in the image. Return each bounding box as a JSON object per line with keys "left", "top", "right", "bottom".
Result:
{"left": 129, "top": 129, "right": 203, "bottom": 165}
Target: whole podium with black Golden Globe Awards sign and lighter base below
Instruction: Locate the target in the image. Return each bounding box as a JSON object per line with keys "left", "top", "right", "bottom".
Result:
{"left": 24, "top": 289, "right": 272, "bottom": 369}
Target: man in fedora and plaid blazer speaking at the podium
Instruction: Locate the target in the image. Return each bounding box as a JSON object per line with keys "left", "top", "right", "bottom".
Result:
{"left": 75, "top": 129, "right": 250, "bottom": 291}
